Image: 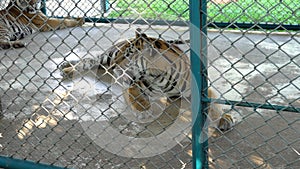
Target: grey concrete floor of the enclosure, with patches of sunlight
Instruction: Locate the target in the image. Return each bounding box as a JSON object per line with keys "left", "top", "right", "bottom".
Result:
{"left": 0, "top": 24, "right": 300, "bottom": 169}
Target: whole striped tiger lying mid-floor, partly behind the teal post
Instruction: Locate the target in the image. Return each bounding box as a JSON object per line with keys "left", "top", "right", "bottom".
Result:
{"left": 59, "top": 28, "right": 234, "bottom": 131}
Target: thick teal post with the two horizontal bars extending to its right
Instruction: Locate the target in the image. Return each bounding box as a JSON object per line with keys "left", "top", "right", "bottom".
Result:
{"left": 190, "top": 0, "right": 300, "bottom": 169}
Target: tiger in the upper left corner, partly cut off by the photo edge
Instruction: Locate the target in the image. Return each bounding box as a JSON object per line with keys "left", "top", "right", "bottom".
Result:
{"left": 0, "top": 0, "right": 84, "bottom": 49}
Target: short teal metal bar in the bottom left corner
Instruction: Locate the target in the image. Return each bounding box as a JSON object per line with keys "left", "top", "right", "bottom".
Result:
{"left": 0, "top": 156, "right": 66, "bottom": 169}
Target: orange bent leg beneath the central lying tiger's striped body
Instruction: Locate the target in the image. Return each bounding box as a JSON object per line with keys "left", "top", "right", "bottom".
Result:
{"left": 124, "top": 84, "right": 150, "bottom": 112}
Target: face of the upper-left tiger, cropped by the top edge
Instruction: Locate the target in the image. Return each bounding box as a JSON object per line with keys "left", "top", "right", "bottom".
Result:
{"left": 15, "top": 0, "right": 41, "bottom": 14}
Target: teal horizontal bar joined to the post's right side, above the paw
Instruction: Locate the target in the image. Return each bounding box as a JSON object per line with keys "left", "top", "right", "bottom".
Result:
{"left": 202, "top": 98, "right": 300, "bottom": 113}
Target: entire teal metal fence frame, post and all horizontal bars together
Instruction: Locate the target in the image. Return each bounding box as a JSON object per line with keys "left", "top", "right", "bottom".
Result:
{"left": 0, "top": 0, "right": 300, "bottom": 169}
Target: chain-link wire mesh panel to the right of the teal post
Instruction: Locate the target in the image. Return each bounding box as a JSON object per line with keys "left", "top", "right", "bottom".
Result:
{"left": 207, "top": 1, "right": 300, "bottom": 168}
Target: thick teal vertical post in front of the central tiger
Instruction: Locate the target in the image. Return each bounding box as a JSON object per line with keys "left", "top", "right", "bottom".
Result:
{"left": 189, "top": 0, "right": 208, "bottom": 169}
